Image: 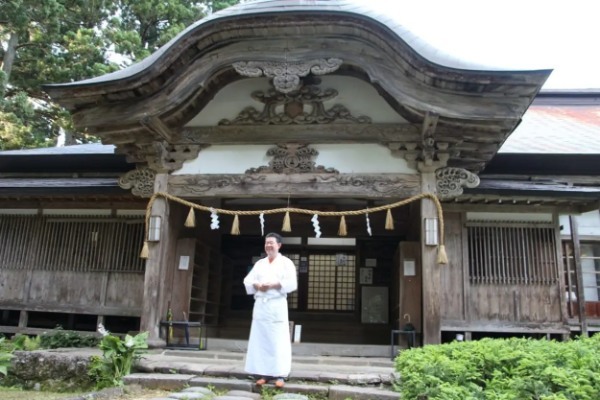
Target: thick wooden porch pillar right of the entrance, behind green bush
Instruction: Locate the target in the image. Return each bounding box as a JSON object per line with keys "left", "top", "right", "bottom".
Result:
{"left": 419, "top": 167, "right": 442, "bottom": 345}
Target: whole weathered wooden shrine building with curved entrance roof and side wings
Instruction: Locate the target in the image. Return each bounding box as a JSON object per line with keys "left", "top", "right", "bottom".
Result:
{"left": 0, "top": 0, "right": 600, "bottom": 344}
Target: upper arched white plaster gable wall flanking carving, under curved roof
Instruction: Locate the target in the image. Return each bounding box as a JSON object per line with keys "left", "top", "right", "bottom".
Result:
{"left": 186, "top": 76, "right": 406, "bottom": 127}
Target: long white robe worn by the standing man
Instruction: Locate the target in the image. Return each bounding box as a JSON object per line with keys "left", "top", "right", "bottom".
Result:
{"left": 244, "top": 254, "right": 298, "bottom": 377}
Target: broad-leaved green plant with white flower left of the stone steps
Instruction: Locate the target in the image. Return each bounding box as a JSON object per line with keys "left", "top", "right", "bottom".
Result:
{"left": 88, "top": 326, "right": 148, "bottom": 389}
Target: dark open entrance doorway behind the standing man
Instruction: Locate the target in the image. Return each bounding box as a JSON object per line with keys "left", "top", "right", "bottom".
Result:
{"left": 220, "top": 235, "right": 402, "bottom": 344}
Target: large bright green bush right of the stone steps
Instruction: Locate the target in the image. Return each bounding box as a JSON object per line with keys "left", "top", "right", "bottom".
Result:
{"left": 394, "top": 335, "right": 600, "bottom": 400}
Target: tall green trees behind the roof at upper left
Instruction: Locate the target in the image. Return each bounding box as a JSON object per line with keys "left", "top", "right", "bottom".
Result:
{"left": 0, "top": 0, "right": 239, "bottom": 150}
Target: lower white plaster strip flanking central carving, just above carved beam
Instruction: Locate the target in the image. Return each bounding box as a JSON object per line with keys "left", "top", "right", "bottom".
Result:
{"left": 172, "top": 144, "right": 417, "bottom": 175}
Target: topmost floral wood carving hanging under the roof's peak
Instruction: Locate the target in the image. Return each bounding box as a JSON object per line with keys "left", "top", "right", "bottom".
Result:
{"left": 233, "top": 58, "right": 342, "bottom": 93}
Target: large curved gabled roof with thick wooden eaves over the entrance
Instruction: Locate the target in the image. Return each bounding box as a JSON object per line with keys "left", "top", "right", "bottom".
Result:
{"left": 45, "top": 0, "right": 550, "bottom": 168}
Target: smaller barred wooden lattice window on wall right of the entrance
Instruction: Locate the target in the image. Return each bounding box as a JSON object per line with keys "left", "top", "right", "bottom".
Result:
{"left": 467, "top": 222, "right": 558, "bottom": 285}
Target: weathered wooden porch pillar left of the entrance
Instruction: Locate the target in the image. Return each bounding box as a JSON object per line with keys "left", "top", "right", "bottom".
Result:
{"left": 140, "top": 173, "right": 170, "bottom": 347}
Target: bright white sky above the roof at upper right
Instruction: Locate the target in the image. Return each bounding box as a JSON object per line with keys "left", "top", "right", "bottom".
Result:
{"left": 359, "top": 0, "right": 600, "bottom": 90}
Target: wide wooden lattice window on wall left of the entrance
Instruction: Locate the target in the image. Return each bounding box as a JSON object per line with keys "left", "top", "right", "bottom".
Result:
{"left": 0, "top": 215, "right": 144, "bottom": 272}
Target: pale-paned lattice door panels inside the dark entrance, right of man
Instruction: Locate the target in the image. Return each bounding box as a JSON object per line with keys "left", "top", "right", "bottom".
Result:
{"left": 308, "top": 254, "right": 356, "bottom": 311}
